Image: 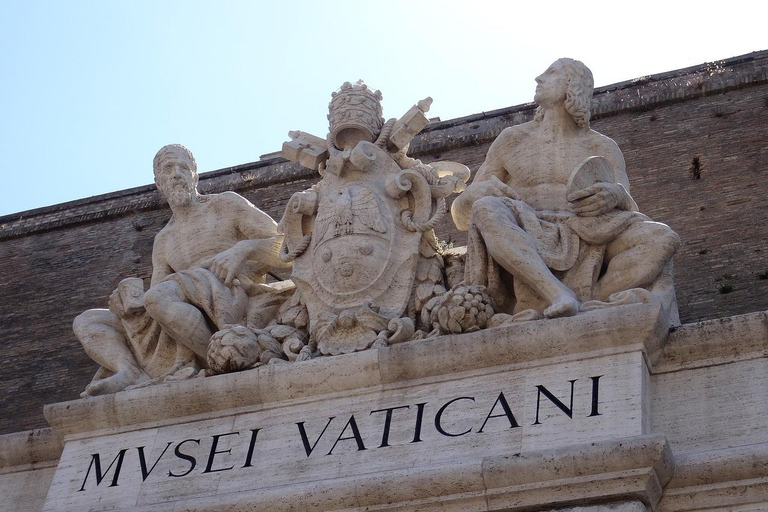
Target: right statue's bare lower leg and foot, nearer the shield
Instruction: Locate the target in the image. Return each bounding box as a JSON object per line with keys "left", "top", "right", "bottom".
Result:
{"left": 472, "top": 196, "right": 579, "bottom": 318}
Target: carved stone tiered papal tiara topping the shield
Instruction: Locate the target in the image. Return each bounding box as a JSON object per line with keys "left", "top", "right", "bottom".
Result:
{"left": 328, "top": 80, "right": 384, "bottom": 147}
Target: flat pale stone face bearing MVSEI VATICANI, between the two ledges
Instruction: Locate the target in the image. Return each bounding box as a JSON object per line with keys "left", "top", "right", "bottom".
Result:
{"left": 44, "top": 354, "right": 659, "bottom": 510}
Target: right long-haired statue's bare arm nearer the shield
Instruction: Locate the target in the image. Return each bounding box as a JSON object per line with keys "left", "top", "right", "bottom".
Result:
{"left": 451, "top": 127, "right": 516, "bottom": 231}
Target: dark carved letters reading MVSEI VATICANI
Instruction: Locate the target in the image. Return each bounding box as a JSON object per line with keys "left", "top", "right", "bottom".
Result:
{"left": 78, "top": 375, "right": 602, "bottom": 492}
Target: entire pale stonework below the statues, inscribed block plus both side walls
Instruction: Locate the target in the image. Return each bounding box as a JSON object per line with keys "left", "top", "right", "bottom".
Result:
{"left": 0, "top": 305, "right": 768, "bottom": 512}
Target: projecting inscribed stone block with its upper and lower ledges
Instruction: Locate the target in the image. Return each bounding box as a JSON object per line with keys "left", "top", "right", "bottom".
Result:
{"left": 43, "top": 304, "right": 674, "bottom": 511}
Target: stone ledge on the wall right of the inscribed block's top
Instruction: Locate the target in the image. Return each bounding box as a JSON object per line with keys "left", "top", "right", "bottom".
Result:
{"left": 653, "top": 311, "right": 768, "bottom": 374}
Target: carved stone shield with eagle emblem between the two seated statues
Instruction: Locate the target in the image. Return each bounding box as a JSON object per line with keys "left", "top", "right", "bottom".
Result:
{"left": 293, "top": 144, "right": 421, "bottom": 319}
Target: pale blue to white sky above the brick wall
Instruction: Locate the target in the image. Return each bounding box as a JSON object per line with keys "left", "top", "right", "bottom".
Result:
{"left": 0, "top": 0, "right": 768, "bottom": 215}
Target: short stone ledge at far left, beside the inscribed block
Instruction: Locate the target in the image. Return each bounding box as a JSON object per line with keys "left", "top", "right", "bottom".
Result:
{"left": 0, "top": 428, "right": 64, "bottom": 474}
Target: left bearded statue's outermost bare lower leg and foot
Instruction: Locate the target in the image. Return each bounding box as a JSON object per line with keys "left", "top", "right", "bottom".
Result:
{"left": 72, "top": 309, "right": 149, "bottom": 397}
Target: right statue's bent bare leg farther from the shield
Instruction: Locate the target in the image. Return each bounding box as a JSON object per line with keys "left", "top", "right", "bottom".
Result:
{"left": 595, "top": 221, "right": 680, "bottom": 301}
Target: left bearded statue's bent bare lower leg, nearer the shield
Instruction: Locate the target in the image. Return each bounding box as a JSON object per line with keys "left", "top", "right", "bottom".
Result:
{"left": 144, "top": 280, "right": 213, "bottom": 361}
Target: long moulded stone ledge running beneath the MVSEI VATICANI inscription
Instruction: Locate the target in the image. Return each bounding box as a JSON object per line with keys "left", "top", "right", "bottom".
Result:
{"left": 93, "top": 436, "right": 674, "bottom": 512}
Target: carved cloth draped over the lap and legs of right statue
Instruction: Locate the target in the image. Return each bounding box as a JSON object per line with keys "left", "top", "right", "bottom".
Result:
{"left": 465, "top": 198, "right": 649, "bottom": 313}
